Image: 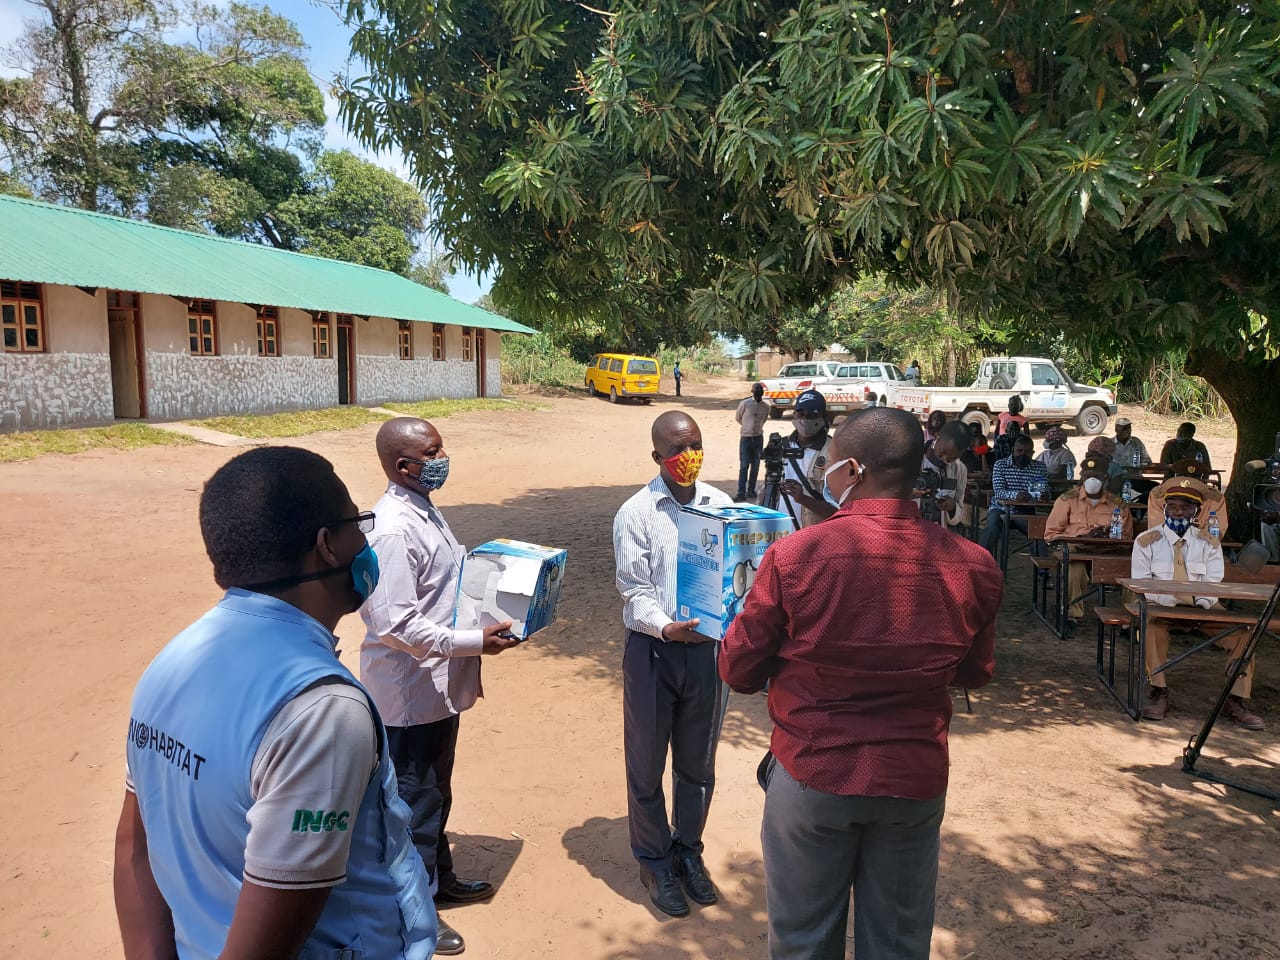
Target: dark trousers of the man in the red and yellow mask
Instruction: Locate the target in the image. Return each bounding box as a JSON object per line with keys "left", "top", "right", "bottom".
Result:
{"left": 622, "top": 631, "right": 728, "bottom": 872}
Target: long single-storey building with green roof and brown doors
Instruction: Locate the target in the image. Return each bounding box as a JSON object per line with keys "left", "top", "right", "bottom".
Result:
{"left": 0, "top": 196, "right": 532, "bottom": 430}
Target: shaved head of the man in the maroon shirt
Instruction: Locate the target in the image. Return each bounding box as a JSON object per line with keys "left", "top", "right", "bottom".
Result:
{"left": 831, "top": 407, "right": 924, "bottom": 499}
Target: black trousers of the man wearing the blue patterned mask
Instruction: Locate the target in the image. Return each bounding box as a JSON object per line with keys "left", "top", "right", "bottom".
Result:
{"left": 387, "top": 714, "right": 458, "bottom": 887}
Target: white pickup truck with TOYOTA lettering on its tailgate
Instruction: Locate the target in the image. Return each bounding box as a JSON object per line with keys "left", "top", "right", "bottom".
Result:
{"left": 890, "top": 357, "right": 1116, "bottom": 436}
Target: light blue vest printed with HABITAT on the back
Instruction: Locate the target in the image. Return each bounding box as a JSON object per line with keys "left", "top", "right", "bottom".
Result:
{"left": 128, "top": 589, "right": 435, "bottom": 960}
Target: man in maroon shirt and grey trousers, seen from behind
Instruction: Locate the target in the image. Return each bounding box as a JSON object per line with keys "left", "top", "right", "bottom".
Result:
{"left": 719, "top": 407, "right": 1004, "bottom": 960}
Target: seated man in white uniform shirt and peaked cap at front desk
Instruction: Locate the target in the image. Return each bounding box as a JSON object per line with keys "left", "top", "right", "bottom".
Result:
{"left": 1130, "top": 480, "right": 1263, "bottom": 730}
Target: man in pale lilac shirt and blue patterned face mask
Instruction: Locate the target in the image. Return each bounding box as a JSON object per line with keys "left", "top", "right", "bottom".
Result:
{"left": 360, "top": 417, "right": 517, "bottom": 956}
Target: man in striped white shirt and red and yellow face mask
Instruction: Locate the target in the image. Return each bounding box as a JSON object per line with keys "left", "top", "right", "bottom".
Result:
{"left": 613, "top": 411, "right": 733, "bottom": 916}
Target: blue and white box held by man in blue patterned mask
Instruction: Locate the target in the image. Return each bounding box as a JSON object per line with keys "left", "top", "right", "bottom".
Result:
{"left": 453, "top": 539, "right": 567, "bottom": 640}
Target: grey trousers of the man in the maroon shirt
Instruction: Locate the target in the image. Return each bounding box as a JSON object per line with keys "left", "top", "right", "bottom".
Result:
{"left": 760, "top": 758, "right": 946, "bottom": 960}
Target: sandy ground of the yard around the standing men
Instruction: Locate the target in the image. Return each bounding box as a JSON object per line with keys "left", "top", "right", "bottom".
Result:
{"left": 0, "top": 381, "right": 1280, "bottom": 960}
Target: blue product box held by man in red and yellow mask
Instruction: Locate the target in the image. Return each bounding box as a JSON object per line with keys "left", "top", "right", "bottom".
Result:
{"left": 676, "top": 503, "right": 795, "bottom": 640}
